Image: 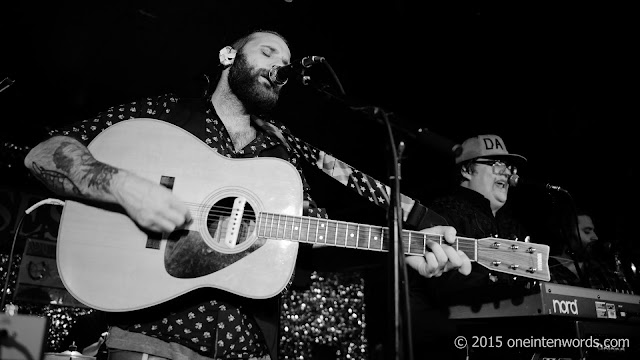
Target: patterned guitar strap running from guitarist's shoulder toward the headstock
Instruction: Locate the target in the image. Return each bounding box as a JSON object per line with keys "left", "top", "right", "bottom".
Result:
{"left": 254, "top": 118, "right": 447, "bottom": 229}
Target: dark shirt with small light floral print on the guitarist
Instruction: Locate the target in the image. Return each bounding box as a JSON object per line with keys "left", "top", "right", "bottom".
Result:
{"left": 50, "top": 94, "right": 327, "bottom": 359}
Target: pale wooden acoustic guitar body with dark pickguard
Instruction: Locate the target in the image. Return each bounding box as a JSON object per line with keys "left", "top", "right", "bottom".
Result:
{"left": 57, "top": 119, "right": 303, "bottom": 311}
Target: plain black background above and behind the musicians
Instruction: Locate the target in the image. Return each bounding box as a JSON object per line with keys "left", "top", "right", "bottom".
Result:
{"left": 0, "top": 0, "right": 638, "bottom": 258}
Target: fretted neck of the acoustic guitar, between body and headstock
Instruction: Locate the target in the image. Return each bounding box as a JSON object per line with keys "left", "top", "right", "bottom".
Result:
{"left": 256, "top": 213, "right": 478, "bottom": 261}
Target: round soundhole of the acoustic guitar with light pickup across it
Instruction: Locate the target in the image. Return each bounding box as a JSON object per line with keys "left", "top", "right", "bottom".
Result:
{"left": 207, "top": 197, "right": 256, "bottom": 249}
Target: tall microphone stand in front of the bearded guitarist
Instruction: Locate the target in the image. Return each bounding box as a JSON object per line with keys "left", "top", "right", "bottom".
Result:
{"left": 300, "top": 69, "right": 413, "bottom": 360}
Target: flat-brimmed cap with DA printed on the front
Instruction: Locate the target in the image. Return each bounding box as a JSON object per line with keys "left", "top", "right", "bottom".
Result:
{"left": 456, "top": 135, "right": 527, "bottom": 165}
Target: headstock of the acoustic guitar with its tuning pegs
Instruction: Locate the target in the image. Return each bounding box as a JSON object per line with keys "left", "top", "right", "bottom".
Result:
{"left": 477, "top": 238, "right": 551, "bottom": 281}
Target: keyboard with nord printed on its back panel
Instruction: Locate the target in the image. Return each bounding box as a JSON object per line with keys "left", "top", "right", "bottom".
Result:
{"left": 449, "top": 282, "right": 640, "bottom": 323}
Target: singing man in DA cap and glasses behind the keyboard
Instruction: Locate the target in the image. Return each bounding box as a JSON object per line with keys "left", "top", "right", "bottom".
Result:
{"left": 410, "top": 135, "right": 527, "bottom": 359}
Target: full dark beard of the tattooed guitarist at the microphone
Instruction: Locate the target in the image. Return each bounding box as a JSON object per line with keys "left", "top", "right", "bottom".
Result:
{"left": 229, "top": 52, "right": 280, "bottom": 115}
